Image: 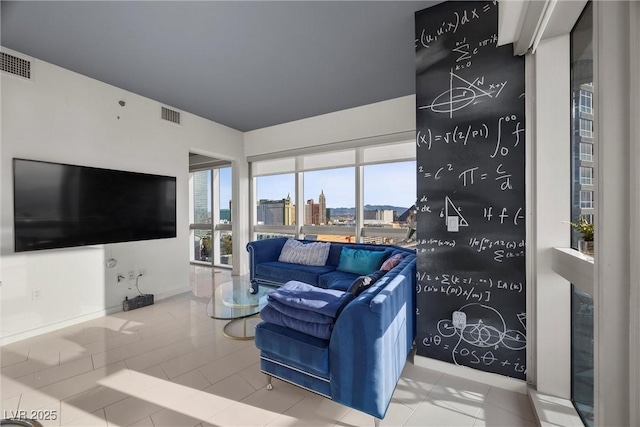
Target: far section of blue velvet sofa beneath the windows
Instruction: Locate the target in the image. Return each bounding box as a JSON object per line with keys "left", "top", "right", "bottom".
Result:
{"left": 247, "top": 237, "right": 415, "bottom": 294}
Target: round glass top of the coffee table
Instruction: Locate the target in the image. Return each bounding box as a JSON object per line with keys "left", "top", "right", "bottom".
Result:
{"left": 207, "top": 278, "right": 275, "bottom": 320}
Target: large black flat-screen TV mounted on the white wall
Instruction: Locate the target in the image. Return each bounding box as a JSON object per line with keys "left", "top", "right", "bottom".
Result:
{"left": 13, "top": 159, "right": 176, "bottom": 252}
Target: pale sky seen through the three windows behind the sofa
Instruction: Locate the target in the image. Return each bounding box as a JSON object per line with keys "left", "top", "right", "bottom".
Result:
{"left": 256, "top": 161, "right": 416, "bottom": 208}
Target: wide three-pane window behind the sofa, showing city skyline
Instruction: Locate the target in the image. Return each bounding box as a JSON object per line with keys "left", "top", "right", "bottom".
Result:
{"left": 251, "top": 140, "right": 416, "bottom": 246}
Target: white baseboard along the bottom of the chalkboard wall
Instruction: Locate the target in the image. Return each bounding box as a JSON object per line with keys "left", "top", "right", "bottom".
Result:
{"left": 414, "top": 355, "right": 528, "bottom": 394}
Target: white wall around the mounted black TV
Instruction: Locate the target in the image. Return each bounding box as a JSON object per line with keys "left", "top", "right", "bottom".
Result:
{"left": 0, "top": 50, "right": 244, "bottom": 343}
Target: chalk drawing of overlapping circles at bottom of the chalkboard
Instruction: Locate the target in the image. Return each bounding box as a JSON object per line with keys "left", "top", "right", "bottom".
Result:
{"left": 422, "top": 302, "right": 527, "bottom": 374}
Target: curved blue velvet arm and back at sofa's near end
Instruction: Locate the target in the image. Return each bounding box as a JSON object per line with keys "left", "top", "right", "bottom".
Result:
{"left": 329, "top": 261, "right": 415, "bottom": 418}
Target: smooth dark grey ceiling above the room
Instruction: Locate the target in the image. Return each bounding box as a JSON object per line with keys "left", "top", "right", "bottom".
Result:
{"left": 0, "top": 0, "right": 439, "bottom": 131}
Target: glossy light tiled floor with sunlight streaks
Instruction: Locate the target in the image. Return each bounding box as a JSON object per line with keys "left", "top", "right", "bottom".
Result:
{"left": 0, "top": 268, "right": 536, "bottom": 427}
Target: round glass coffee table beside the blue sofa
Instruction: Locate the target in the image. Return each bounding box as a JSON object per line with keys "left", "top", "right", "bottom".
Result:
{"left": 207, "top": 277, "right": 276, "bottom": 340}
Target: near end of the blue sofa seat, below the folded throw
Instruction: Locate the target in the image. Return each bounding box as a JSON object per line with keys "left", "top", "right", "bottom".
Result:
{"left": 255, "top": 322, "right": 329, "bottom": 378}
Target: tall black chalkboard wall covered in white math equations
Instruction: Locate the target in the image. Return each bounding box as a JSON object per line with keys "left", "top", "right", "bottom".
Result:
{"left": 415, "top": 1, "right": 526, "bottom": 379}
